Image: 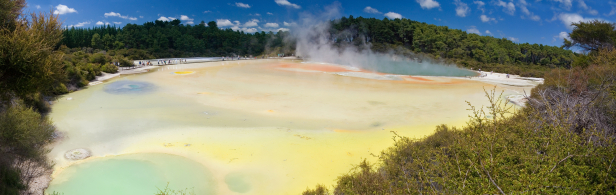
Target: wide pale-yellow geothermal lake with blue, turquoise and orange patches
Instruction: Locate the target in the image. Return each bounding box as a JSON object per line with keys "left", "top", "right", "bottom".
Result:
{"left": 47, "top": 60, "right": 530, "bottom": 195}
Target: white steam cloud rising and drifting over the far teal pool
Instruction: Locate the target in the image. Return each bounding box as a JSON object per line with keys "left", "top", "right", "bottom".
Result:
{"left": 291, "top": 3, "right": 476, "bottom": 76}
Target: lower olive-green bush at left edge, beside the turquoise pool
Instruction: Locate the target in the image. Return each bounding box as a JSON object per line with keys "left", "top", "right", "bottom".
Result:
{"left": 0, "top": 101, "right": 55, "bottom": 194}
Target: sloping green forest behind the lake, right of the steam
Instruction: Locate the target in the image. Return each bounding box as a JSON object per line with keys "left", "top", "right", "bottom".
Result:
{"left": 330, "top": 16, "right": 574, "bottom": 71}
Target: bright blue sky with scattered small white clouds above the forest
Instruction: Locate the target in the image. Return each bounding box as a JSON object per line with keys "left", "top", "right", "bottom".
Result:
{"left": 21, "top": 0, "right": 616, "bottom": 46}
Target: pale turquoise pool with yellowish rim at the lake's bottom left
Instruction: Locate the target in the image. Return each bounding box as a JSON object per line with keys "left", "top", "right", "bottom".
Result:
{"left": 46, "top": 154, "right": 215, "bottom": 195}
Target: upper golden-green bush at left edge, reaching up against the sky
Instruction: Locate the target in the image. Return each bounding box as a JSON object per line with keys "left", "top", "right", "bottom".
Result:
{"left": 0, "top": 10, "right": 63, "bottom": 105}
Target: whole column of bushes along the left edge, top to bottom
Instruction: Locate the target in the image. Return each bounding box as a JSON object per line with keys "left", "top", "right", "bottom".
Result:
{"left": 0, "top": 0, "right": 64, "bottom": 195}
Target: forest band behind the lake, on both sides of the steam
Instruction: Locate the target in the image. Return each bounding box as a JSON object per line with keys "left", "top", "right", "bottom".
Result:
{"left": 59, "top": 16, "right": 581, "bottom": 77}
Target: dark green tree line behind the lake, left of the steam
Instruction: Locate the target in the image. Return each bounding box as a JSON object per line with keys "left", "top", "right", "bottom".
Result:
{"left": 61, "top": 20, "right": 293, "bottom": 60}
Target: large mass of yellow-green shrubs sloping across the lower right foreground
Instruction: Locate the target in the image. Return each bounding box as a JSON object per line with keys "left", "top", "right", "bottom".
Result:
{"left": 306, "top": 86, "right": 616, "bottom": 194}
